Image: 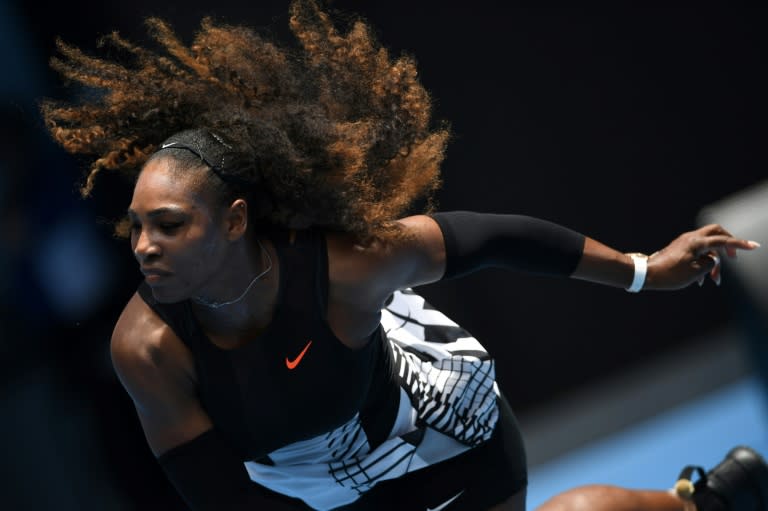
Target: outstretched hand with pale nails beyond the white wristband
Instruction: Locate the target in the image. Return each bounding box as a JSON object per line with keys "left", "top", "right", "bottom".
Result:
{"left": 643, "top": 224, "right": 760, "bottom": 290}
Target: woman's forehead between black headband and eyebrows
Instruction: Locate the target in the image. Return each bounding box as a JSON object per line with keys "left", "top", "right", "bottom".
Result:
{"left": 130, "top": 158, "right": 208, "bottom": 213}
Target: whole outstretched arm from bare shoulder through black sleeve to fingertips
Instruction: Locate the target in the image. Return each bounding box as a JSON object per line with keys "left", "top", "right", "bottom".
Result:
{"left": 329, "top": 211, "right": 759, "bottom": 310}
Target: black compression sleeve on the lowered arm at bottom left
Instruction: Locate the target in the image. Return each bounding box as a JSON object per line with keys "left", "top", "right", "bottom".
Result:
{"left": 157, "top": 429, "right": 308, "bottom": 511}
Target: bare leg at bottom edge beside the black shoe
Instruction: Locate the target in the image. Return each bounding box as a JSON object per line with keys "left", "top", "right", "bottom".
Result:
{"left": 536, "top": 485, "right": 696, "bottom": 511}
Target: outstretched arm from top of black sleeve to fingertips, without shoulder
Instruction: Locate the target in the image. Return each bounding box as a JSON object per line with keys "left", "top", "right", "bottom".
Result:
{"left": 433, "top": 211, "right": 757, "bottom": 289}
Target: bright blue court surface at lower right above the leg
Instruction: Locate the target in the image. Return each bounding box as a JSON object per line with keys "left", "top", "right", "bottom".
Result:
{"left": 527, "top": 376, "right": 768, "bottom": 510}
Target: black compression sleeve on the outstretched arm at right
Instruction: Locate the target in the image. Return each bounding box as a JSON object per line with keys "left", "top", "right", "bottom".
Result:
{"left": 432, "top": 211, "right": 585, "bottom": 279}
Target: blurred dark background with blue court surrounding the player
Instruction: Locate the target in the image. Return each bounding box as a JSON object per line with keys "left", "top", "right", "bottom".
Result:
{"left": 0, "top": 0, "right": 768, "bottom": 510}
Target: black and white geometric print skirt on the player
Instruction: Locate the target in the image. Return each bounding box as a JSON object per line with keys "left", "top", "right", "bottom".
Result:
{"left": 245, "top": 289, "right": 499, "bottom": 510}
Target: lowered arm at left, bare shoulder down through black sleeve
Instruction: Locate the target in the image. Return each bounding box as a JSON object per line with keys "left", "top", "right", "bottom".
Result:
{"left": 111, "top": 295, "right": 292, "bottom": 511}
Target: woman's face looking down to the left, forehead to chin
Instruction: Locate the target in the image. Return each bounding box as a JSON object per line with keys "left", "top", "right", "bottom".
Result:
{"left": 128, "top": 158, "right": 230, "bottom": 303}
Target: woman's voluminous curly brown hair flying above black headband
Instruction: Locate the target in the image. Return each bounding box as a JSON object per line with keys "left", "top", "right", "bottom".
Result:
{"left": 41, "top": 0, "right": 449, "bottom": 239}
